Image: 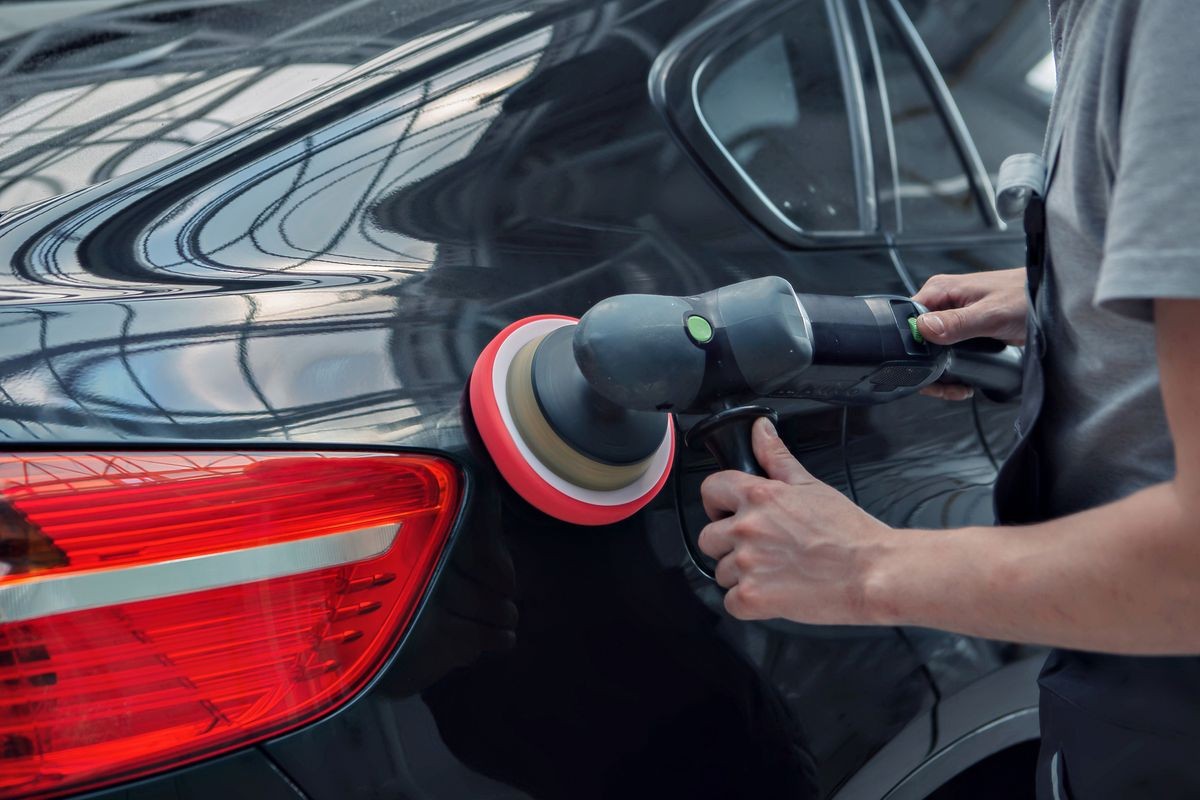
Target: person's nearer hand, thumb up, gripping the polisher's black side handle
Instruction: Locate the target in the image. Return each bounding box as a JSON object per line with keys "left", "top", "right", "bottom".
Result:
{"left": 700, "top": 419, "right": 890, "bottom": 625}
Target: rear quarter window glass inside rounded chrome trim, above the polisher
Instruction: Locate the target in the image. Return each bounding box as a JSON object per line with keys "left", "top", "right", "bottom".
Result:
{"left": 696, "top": 2, "right": 862, "bottom": 231}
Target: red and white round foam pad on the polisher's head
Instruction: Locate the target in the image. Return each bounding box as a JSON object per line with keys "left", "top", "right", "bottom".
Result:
{"left": 468, "top": 314, "right": 674, "bottom": 525}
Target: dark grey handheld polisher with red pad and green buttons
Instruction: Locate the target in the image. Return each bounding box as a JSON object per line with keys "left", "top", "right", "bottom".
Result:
{"left": 469, "top": 277, "right": 1021, "bottom": 525}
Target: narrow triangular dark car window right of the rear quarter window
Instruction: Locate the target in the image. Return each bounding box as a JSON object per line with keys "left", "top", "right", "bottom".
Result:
{"left": 870, "top": 2, "right": 985, "bottom": 234}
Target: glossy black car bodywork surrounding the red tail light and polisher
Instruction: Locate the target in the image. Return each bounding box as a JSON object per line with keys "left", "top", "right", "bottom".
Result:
{"left": 0, "top": 0, "right": 1051, "bottom": 798}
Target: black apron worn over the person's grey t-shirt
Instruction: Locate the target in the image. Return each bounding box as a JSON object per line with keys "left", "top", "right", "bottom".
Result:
{"left": 995, "top": 115, "right": 1200, "bottom": 800}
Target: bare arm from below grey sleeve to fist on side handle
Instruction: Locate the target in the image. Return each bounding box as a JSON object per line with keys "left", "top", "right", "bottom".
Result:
{"left": 700, "top": 300, "right": 1200, "bottom": 655}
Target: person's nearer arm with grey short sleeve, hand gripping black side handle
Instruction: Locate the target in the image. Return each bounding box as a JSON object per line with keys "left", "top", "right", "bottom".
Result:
{"left": 700, "top": 0, "right": 1200, "bottom": 655}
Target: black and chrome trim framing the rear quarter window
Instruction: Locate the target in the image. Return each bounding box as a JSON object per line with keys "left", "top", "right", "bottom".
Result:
{"left": 648, "top": 0, "right": 886, "bottom": 248}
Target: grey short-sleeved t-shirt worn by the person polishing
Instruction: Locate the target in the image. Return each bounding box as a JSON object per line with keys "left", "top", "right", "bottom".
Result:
{"left": 1038, "top": 0, "right": 1200, "bottom": 516}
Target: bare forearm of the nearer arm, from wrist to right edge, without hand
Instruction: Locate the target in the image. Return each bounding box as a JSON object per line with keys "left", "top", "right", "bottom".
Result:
{"left": 864, "top": 483, "right": 1200, "bottom": 655}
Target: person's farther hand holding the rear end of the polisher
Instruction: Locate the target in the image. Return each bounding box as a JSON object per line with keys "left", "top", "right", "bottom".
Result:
{"left": 913, "top": 267, "right": 1028, "bottom": 399}
